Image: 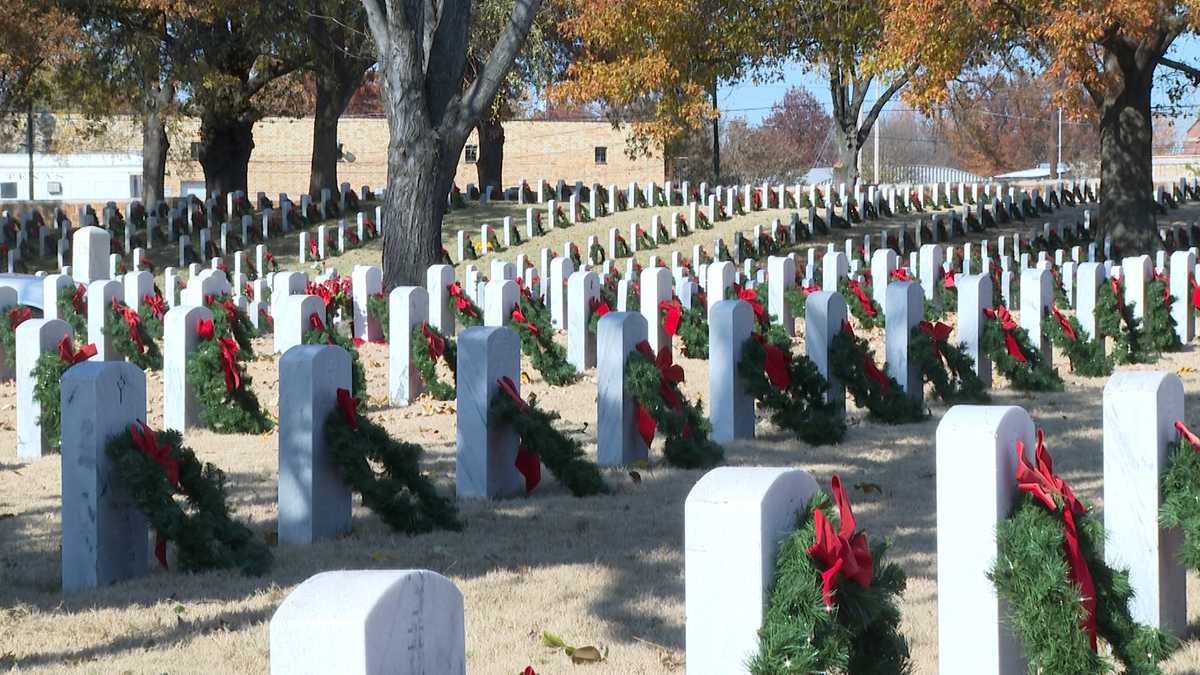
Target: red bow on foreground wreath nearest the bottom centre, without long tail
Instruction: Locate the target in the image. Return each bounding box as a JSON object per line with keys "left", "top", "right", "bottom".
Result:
{"left": 808, "top": 476, "right": 875, "bottom": 607}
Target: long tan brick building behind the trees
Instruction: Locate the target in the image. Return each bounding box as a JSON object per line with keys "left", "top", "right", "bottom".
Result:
{"left": 0, "top": 115, "right": 665, "bottom": 202}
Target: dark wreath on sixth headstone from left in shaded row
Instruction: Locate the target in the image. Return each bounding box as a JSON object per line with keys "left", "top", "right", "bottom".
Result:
{"left": 829, "top": 321, "right": 925, "bottom": 424}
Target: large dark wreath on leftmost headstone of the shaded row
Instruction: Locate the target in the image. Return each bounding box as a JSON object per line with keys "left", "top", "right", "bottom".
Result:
{"left": 104, "top": 420, "right": 272, "bottom": 577}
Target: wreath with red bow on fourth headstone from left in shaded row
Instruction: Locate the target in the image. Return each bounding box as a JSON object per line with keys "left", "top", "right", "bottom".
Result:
{"left": 625, "top": 340, "right": 725, "bottom": 468}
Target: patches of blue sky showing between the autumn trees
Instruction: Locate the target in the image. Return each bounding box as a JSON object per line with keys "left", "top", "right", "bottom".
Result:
{"left": 718, "top": 36, "right": 1200, "bottom": 127}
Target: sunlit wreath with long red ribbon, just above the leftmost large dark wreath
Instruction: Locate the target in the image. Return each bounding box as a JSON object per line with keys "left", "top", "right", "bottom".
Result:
{"left": 185, "top": 319, "right": 272, "bottom": 434}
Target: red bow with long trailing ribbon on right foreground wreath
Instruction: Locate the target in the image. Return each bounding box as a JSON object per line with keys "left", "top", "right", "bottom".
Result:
{"left": 1016, "top": 429, "right": 1096, "bottom": 652}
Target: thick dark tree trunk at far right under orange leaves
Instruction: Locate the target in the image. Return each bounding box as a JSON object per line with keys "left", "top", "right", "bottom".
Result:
{"left": 1099, "top": 72, "right": 1163, "bottom": 255}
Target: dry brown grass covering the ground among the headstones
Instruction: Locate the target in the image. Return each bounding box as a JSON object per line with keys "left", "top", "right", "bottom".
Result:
{"left": 0, "top": 196, "right": 1200, "bottom": 675}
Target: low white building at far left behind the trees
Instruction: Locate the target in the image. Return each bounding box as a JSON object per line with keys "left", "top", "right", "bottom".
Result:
{"left": 0, "top": 153, "right": 142, "bottom": 203}
